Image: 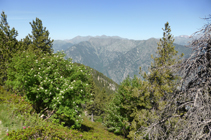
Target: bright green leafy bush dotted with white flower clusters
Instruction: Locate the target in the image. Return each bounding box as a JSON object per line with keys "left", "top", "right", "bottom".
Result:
{"left": 6, "top": 51, "right": 90, "bottom": 127}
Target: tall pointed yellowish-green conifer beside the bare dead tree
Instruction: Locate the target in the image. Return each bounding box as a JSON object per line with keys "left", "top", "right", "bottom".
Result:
{"left": 140, "top": 22, "right": 184, "bottom": 109}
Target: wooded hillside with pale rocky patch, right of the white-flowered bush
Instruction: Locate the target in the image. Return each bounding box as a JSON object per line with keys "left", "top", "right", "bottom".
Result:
{"left": 74, "top": 63, "right": 118, "bottom": 122}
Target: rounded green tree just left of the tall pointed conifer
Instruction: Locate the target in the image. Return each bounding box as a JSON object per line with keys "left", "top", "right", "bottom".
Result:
{"left": 105, "top": 76, "right": 151, "bottom": 137}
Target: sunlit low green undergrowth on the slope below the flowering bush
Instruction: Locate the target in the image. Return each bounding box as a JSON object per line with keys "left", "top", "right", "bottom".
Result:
{"left": 0, "top": 87, "right": 123, "bottom": 140}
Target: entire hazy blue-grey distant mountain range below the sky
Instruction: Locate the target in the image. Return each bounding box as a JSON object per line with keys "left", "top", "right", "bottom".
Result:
{"left": 53, "top": 35, "right": 191, "bottom": 83}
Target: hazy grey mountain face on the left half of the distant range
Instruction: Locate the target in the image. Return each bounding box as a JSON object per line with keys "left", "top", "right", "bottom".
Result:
{"left": 65, "top": 38, "right": 144, "bottom": 72}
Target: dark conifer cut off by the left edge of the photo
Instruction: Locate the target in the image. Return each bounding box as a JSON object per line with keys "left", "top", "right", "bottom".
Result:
{"left": 0, "top": 11, "right": 18, "bottom": 85}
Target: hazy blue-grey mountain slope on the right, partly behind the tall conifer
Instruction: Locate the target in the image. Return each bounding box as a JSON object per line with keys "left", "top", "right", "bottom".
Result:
{"left": 103, "top": 38, "right": 190, "bottom": 83}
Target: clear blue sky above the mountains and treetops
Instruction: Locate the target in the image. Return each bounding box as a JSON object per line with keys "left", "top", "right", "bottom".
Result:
{"left": 0, "top": 0, "right": 211, "bottom": 40}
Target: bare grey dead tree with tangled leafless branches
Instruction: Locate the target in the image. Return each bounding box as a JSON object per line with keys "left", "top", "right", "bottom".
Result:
{"left": 134, "top": 15, "right": 211, "bottom": 140}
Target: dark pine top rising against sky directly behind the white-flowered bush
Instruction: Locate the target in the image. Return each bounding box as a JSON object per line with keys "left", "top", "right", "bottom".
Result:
{"left": 28, "top": 18, "right": 53, "bottom": 54}
